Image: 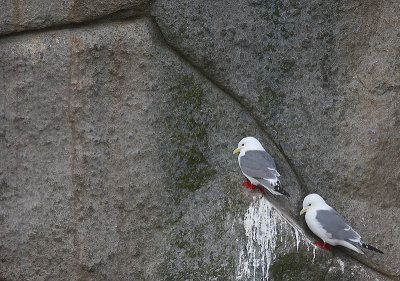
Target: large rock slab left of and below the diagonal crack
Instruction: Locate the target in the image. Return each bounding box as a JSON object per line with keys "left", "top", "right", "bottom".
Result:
{"left": 0, "top": 20, "right": 299, "bottom": 280}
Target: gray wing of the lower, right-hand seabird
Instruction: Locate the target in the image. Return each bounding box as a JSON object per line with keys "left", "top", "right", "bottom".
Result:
{"left": 316, "top": 209, "right": 361, "bottom": 242}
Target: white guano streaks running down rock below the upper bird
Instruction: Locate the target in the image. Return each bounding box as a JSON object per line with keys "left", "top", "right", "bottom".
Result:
{"left": 236, "top": 196, "right": 315, "bottom": 281}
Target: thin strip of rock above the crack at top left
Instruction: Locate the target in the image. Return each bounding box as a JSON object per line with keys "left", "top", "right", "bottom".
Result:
{"left": 0, "top": 0, "right": 148, "bottom": 35}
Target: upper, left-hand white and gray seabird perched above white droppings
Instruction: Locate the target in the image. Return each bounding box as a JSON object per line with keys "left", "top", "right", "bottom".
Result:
{"left": 233, "top": 137, "right": 290, "bottom": 197}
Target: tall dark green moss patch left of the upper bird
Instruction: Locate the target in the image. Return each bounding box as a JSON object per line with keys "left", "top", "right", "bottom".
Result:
{"left": 168, "top": 75, "right": 213, "bottom": 191}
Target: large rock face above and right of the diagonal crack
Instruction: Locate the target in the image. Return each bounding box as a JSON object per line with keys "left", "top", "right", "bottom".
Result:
{"left": 152, "top": 0, "right": 400, "bottom": 276}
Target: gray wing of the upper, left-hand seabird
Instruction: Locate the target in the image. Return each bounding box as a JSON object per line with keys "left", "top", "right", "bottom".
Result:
{"left": 240, "top": 150, "right": 279, "bottom": 179}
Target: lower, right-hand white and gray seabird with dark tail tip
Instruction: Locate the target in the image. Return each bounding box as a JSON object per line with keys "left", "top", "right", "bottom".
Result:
{"left": 300, "top": 193, "right": 383, "bottom": 254}
